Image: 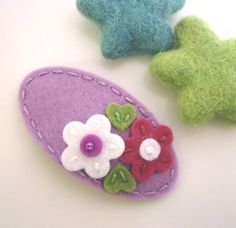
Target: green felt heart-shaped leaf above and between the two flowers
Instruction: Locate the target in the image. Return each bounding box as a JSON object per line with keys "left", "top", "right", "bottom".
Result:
{"left": 106, "top": 103, "right": 136, "bottom": 131}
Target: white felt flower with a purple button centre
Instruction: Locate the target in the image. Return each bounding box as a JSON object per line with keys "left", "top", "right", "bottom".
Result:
{"left": 61, "top": 114, "right": 125, "bottom": 179}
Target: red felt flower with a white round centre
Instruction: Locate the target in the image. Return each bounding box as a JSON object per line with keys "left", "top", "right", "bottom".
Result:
{"left": 121, "top": 119, "right": 173, "bottom": 182}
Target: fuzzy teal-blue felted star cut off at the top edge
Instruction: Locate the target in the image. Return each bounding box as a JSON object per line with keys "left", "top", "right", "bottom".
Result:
{"left": 77, "top": 0, "right": 185, "bottom": 59}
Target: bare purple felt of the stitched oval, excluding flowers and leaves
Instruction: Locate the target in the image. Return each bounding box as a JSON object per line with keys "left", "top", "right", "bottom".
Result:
{"left": 19, "top": 67, "right": 178, "bottom": 199}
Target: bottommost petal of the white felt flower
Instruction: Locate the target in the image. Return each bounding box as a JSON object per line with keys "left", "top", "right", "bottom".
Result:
{"left": 85, "top": 159, "right": 110, "bottom": 179}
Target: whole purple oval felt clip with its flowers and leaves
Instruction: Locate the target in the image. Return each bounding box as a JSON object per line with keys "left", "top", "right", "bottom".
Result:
{"left": 19, "top": 67, "right": 178, "bottom": 199}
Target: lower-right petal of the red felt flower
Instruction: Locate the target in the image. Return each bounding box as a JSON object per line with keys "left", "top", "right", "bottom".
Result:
{"left": 153, "top": 148, "right": 173, "bottom": 172}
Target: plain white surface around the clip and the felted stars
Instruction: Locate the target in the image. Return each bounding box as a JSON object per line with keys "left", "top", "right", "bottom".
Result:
{"left": 0, "top": 0, "right": 236, "bottom": 228}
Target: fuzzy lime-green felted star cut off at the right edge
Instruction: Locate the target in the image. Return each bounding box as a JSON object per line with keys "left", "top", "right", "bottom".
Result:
{"left": 151, "top": 16, "right": 236, "bottom": 124}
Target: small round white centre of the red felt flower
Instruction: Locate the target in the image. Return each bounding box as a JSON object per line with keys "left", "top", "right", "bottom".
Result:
{"left": 139, "top": 138, "right": 161, "bottom": 161}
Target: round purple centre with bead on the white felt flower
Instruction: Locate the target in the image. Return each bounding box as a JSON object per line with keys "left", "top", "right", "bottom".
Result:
{"left": 80, "top": 134, "right": 102, "bottom": 157}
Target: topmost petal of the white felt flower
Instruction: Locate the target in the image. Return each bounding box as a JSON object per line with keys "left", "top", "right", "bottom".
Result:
{"left": 86, "top": 114, "right": 111, "bottom": 133}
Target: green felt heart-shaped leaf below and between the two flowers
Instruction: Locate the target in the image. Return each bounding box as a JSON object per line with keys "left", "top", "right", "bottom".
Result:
{"left": 103, "top": 163, "right": 136, "bottom": 193}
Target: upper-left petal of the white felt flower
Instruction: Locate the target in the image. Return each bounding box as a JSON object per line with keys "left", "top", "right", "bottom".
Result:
{"left": 63, "top": 121, "right": 85, "bottom": 145}
